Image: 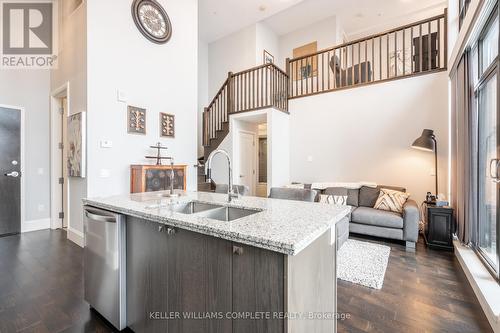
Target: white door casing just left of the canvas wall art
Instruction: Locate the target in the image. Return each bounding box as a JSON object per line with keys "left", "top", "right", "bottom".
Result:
{"left": 50, "top": 82, "right": 71, "bottom": 230}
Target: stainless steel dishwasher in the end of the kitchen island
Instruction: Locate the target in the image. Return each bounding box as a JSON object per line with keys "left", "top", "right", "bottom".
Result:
{"left": 83, "top": 206, "right": 127, "bottom": 330}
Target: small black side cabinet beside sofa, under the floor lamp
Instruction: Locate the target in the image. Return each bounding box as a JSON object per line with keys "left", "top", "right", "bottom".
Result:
{"left": 424, "top": 205, "right": 455, "bottom": 251}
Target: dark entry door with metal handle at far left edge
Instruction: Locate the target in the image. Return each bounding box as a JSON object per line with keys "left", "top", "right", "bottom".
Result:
{"left": 0, "top": 105, "right": 24, "bottom": 236}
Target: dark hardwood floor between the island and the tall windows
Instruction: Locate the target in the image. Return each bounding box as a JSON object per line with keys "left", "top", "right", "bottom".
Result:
{"left": 338, "top": 237, "right": 493, "bottom": 333}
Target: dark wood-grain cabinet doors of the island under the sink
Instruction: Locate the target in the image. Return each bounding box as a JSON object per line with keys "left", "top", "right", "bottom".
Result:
{"left": 127, "top": 217, "right": 285, "bottom": 333}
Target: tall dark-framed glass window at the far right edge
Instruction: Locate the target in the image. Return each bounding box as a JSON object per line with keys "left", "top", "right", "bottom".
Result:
{"left": 471, "top": 10, "right": 500, "bottom": 279}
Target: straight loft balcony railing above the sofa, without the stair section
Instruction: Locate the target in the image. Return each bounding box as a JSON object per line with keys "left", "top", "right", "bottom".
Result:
{"left": 286, "top": 10, "right": 447, "bottom": 98}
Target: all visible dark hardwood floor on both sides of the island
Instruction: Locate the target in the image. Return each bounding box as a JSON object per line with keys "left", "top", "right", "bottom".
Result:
{"left": 0, "top": 231, "right": 491, "bottom": 333}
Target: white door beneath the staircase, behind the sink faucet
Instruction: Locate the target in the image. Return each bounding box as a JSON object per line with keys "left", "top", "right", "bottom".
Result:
{"left": 237, "top": 131, "right": 255, "bottom": 195}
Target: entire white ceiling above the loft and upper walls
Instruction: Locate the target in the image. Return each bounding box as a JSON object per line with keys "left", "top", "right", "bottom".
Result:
{"left": 199, "top": 0, "right": 446, "bottom": 42}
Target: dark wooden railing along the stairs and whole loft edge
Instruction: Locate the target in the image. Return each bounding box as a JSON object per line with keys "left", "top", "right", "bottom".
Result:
{"left": 203, "top": 9, "right": 447, "bottom": 170}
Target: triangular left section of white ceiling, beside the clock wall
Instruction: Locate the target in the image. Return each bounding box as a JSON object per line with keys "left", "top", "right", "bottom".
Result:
{"left": 198, "top": 0, "right": 303, "bottom": 43}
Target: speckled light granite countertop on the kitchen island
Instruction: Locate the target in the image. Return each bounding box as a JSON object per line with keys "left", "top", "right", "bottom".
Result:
{"left": 83, "top": 192, "right": 350, "bottom": 255}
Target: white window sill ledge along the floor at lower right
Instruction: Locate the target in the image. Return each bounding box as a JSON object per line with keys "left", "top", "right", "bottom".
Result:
{"left": 453, "top": 240, "right": 500, "bottom": 333}
